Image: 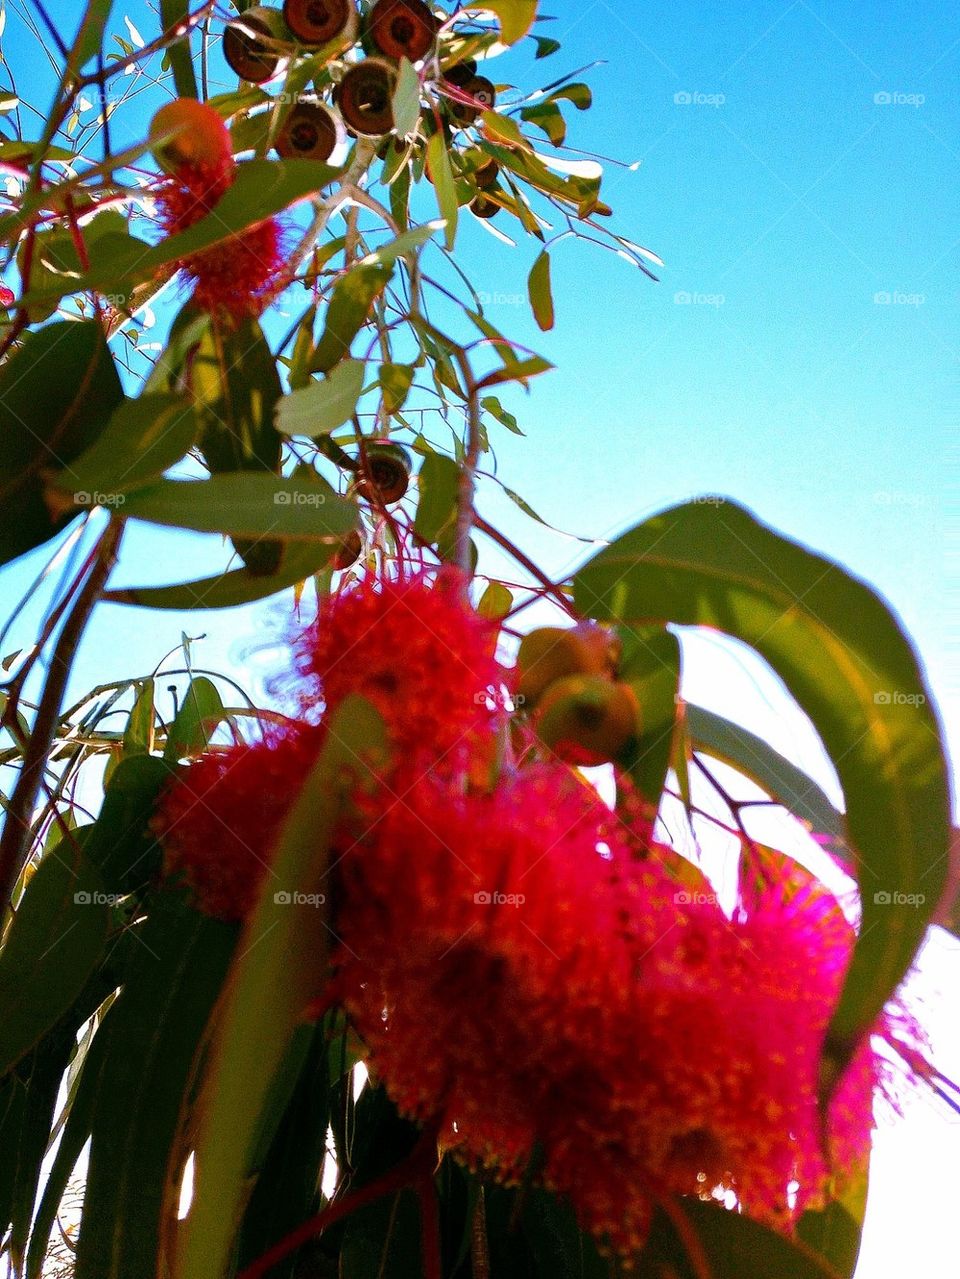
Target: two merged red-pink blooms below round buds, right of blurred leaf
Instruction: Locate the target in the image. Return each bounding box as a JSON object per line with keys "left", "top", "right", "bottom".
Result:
{"left": 337, "top": 765, "right": 925, "bottom": 1253}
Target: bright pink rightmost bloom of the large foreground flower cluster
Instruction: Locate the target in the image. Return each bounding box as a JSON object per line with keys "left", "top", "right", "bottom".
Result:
{"left": 559, "top": 849, "right": 920, "bottom": 1252}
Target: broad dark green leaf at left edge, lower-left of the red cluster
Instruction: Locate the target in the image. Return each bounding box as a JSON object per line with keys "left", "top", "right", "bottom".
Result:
{"left": 0, "top": 842, "right": 110, "bottom": 1076}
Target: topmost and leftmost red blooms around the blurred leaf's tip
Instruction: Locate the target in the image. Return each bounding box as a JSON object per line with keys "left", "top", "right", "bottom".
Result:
{"left": 155, "top": 569, "right": 502, "bottom": 920}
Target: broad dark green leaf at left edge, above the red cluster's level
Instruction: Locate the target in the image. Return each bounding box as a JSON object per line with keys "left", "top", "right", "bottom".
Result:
{"left": 0, "top": 321, "right": 123, "bottom": 564}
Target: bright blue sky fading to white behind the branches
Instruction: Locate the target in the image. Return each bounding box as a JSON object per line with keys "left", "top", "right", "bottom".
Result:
{"left": 0, "top": 0, "right": 960, "bottom": 1279}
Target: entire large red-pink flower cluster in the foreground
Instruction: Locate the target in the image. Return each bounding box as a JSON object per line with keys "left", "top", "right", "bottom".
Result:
{"left": 157, "top": 569, "right": 925, "bottom": 1255}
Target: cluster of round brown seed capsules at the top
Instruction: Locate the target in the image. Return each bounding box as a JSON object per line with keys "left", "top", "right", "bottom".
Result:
{"left": 222, "top": 0, "right": 501, "bottom": 219}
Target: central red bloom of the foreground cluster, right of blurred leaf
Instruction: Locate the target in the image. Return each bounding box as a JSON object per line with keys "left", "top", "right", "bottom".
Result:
{"left": 337, "top": 766, "right": 628, "bottom": 1181}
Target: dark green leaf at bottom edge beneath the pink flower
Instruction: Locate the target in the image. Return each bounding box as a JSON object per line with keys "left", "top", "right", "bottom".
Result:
{"left": 638, "top": 1198, "right": 840, "bottom": 1279}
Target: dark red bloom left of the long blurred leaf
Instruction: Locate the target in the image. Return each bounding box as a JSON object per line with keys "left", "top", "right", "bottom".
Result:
{"left": 152, "top": 728, "right": 323, "bottom": 920}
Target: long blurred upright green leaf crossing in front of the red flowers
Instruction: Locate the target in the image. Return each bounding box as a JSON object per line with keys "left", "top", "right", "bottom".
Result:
{"left": 161, "top": 698, "right": 385, "bottom": 1279}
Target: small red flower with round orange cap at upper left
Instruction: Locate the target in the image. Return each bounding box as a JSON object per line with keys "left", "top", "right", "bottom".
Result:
{"left": 151, "top": 98, "right": 284, "bottom": 320}
